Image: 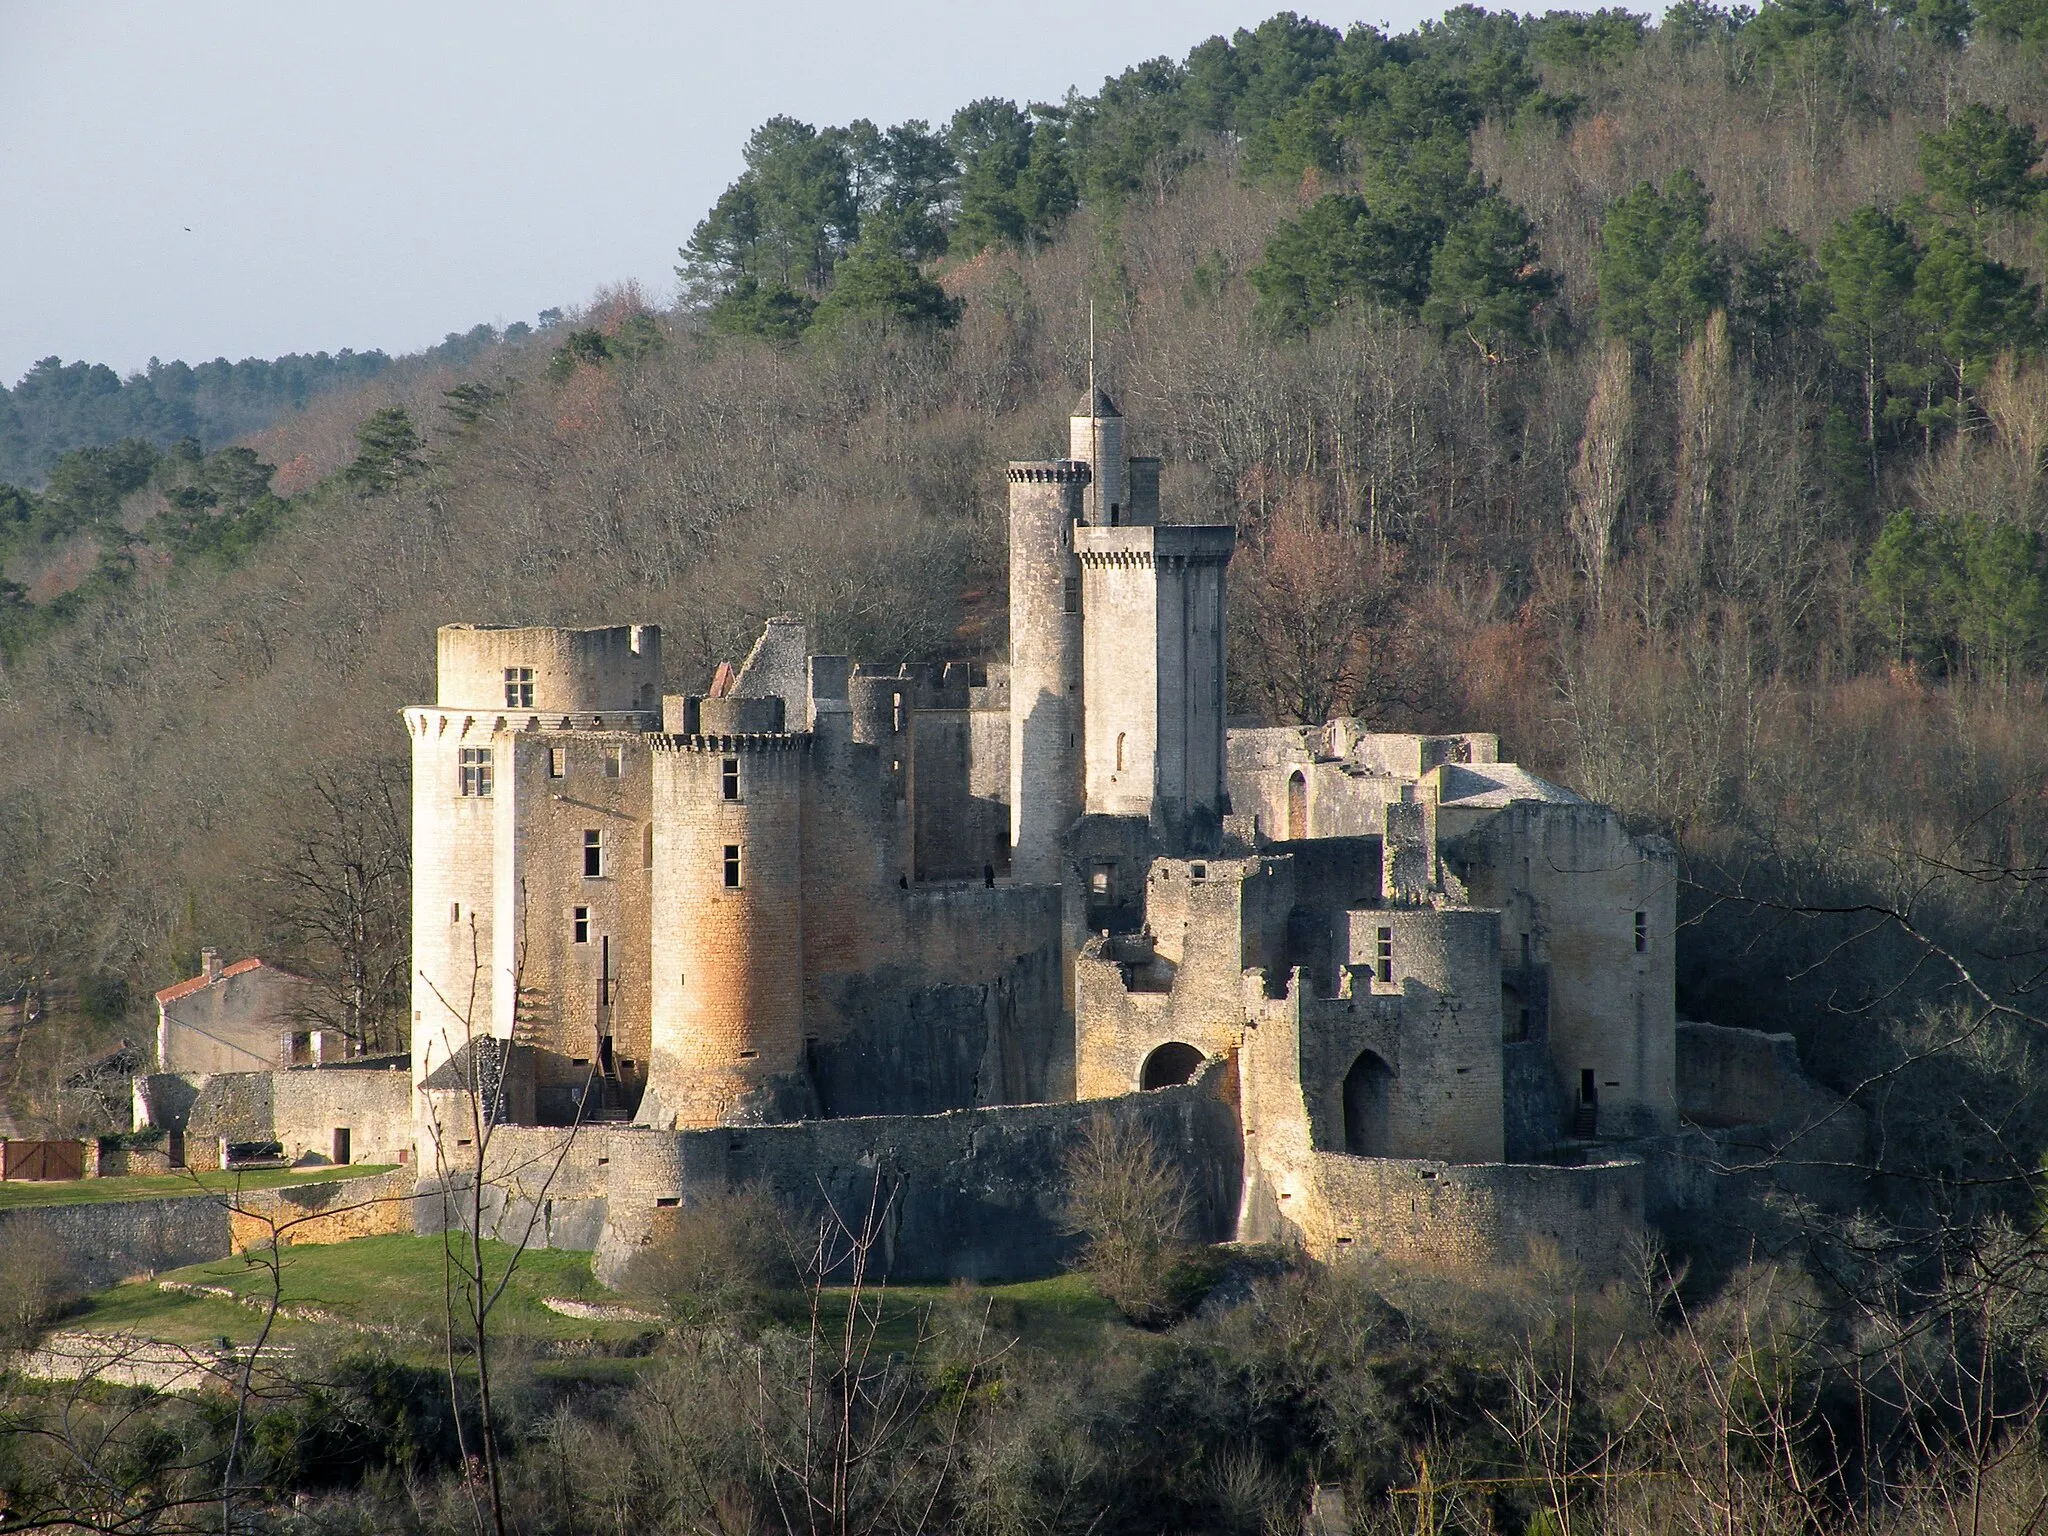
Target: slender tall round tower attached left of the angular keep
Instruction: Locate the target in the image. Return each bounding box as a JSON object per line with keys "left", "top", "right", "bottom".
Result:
{"left": 1010, "top": 459, "right": 1090, "bottom": 885}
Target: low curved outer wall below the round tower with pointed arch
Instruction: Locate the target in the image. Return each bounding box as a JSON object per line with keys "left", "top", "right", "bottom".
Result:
{"left": 1278, "top": 1153, "right": 1645, "bottom": 1280}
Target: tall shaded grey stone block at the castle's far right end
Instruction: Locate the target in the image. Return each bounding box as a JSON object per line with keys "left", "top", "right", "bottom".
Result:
{"left": 1446, "top": 803, "right": 1677, "bottom": 1137}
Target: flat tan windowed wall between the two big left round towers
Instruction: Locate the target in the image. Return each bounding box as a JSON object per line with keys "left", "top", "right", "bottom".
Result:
{"left": 492, "top": 731, "right": 653, "bottom": 1118}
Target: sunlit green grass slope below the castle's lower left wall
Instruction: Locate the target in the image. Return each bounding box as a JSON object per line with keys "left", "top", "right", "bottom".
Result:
{"left": 66, "top": 1237, "right": 645, "bottom": 1343}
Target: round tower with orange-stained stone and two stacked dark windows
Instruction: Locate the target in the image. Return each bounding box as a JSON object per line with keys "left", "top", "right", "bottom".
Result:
{"left": 639, "top": 720, "right": 811, "bottom": 1128}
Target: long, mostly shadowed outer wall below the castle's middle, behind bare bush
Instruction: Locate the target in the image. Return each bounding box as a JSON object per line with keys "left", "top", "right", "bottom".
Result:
{"left": 598, "top": 1069, "right": 1241, "bottom": 1282}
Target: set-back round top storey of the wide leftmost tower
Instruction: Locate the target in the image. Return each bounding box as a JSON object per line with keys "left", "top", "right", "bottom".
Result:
{"left": 434, "top": 625, "right": 662, "bottom": 713}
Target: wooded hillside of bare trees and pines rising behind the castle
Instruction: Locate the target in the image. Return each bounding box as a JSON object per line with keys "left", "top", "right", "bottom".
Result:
{"left": 0, "top": 0, "right": 2048, "bottom": 1157}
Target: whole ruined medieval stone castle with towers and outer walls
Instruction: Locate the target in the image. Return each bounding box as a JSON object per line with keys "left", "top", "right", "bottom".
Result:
{"left": 128, "top": 391, "right": 1859, "bottom": 1278}
